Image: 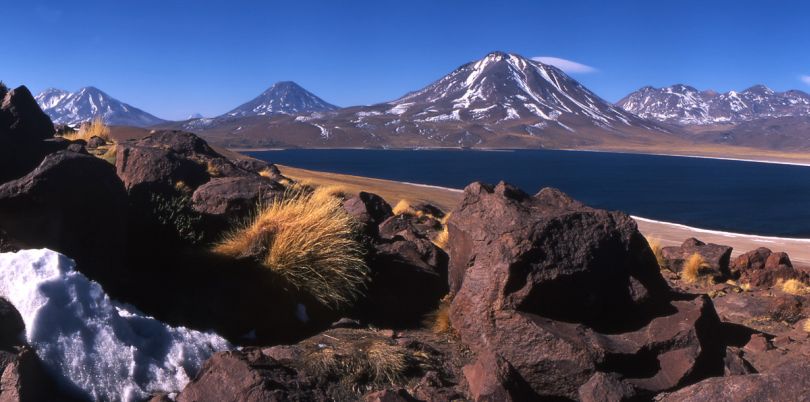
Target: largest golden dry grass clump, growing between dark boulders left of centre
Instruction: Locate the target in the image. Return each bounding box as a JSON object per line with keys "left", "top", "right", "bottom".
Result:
{"left": 214, "top": 191, "right": 369, "bottom": 308}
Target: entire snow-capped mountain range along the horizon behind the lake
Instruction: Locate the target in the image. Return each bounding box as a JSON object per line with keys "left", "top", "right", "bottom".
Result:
{"left": 31, "top": 52, "right": 810, "bottom": 149}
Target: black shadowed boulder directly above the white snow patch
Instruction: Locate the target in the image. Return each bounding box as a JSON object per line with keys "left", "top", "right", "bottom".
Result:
{"left": 0, "top": 151, "right": 127, "bottom": 277}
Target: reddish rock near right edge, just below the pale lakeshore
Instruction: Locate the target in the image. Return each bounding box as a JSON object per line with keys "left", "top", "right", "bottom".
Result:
{"left": 731, "top": 247, "right": 810, "bottom": 288}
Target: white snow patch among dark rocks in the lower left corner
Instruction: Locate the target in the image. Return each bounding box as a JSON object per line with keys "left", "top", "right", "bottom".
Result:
{"left": 0, "top": 249, "right": 231, "bottom": 401}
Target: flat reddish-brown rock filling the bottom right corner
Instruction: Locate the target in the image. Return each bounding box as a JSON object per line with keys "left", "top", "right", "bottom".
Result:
{"left": 656, "top": 360, "right": 810, "bottom": 402}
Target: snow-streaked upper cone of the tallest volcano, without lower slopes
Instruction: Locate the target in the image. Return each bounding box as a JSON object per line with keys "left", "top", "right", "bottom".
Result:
{"left": 388, "top": 52, "right": 642, "bottom": 127}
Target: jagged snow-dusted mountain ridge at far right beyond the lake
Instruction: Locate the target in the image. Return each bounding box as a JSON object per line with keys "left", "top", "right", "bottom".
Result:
{"left": 616, "top": 84, "right": 810, "bottom": 125}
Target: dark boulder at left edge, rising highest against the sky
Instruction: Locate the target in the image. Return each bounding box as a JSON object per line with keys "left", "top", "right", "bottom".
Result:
{"left": 0, "top": 86, "right": 67, "bottom": 183}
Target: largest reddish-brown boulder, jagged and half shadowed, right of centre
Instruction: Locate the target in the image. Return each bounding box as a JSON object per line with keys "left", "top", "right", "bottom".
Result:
{"left": 448, "top": 183, "right": 723, "bottom": 399}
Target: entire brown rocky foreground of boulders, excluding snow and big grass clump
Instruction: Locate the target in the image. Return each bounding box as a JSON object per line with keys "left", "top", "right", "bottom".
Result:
{"left": 0, "top": 83, "right": 810, "bottom": 401}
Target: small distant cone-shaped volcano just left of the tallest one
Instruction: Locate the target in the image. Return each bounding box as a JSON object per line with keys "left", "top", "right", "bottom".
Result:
{"left": 224, "top": 81, "right": 337, "bottom": 117}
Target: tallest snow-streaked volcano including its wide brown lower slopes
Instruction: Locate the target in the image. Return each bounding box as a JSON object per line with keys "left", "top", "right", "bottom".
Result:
{"left": 173, "top": 52, "right": 672, "bottom": 148}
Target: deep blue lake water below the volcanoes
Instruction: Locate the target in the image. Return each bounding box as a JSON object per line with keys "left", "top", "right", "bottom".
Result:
{"left": 248, "top": 150, "right": 810, "bottom": 237}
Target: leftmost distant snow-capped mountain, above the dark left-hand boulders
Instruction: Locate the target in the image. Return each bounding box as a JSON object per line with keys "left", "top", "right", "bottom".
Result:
{"left": 36, "top": 87, "right": 165, "bottom": 127}
